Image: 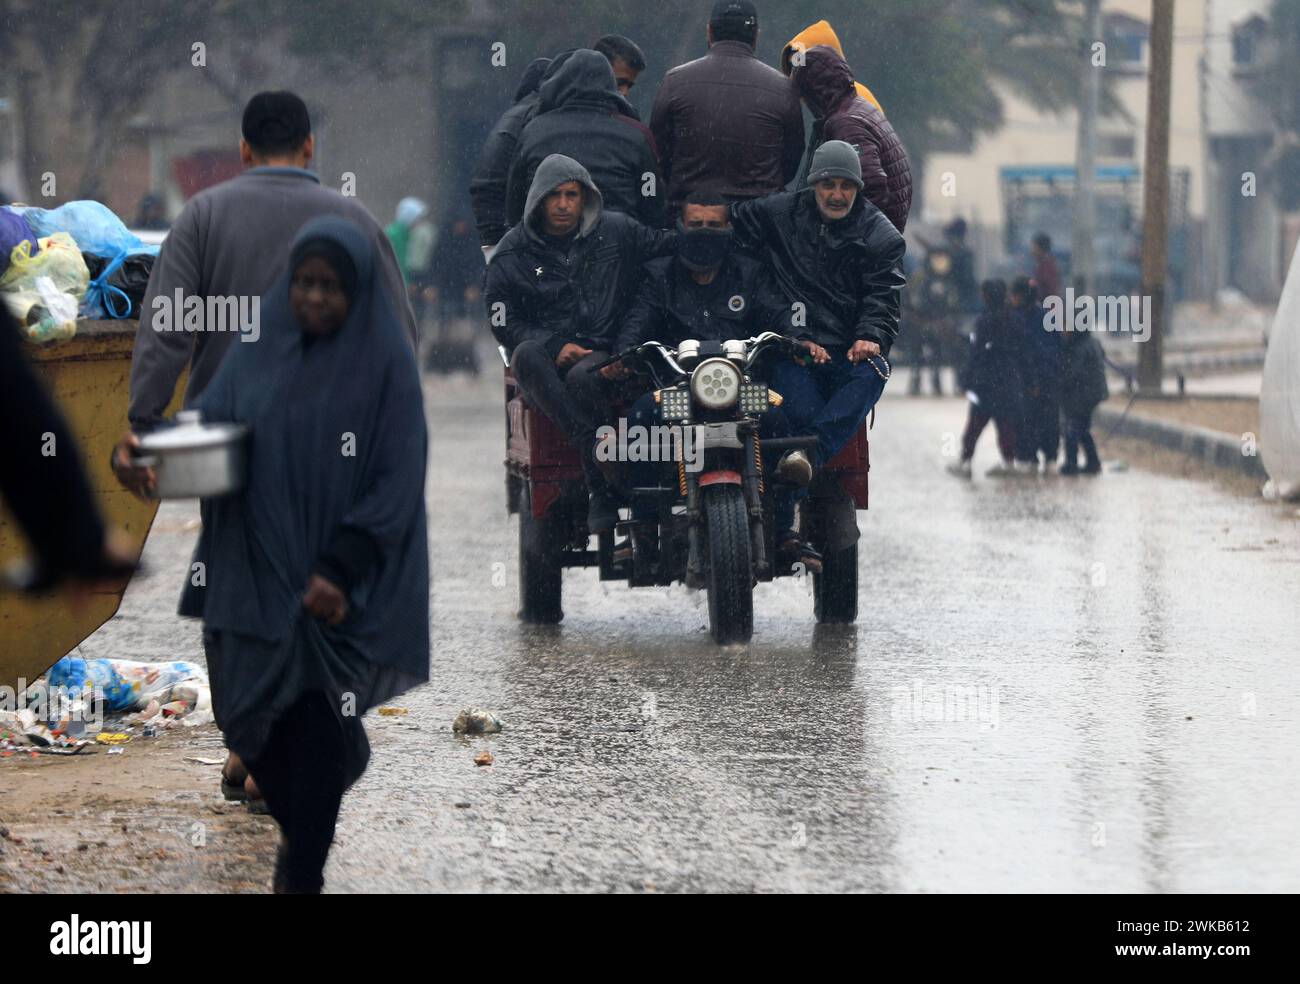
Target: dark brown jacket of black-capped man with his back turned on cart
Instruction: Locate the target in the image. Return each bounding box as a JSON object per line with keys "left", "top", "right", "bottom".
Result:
{"left": 650, "top": 40, "right": 803, "bottom": 209}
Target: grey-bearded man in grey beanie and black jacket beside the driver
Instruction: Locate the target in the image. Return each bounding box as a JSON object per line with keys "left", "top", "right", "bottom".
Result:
{"left": 729, "top": 140, "right": 906, "bottom": 564}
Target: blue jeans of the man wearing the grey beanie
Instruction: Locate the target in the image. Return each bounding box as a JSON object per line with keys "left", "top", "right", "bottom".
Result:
{"left": 770, "top": 350, "right": 889, "bottom": 530}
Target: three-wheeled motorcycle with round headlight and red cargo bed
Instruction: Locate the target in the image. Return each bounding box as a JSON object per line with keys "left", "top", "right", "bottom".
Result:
{"left": 503, "top": 331, "right": 870, "bottom": 643}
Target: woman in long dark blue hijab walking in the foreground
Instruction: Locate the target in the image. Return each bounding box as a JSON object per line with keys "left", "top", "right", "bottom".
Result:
{"left": 188, "top": 217, "right": 429, "bottom": 893}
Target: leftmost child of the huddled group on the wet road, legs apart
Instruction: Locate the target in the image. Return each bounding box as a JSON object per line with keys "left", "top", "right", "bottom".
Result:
{"left": 948, "top": 281, "right": 1023, "bottom": 478}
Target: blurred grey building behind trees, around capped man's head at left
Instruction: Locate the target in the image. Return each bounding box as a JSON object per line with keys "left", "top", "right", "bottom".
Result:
{"left": 85, "top": 9, "right": 501, "bottom": 232}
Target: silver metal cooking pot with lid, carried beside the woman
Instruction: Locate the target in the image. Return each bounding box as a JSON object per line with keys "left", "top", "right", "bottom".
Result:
{"left": 135, "top": 409, "right": 248, "bottom": 499}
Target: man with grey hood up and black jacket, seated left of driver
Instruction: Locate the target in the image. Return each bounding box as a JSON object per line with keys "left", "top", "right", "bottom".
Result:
{"left": 484, "top": 154, "right": 676, "bottom": 533}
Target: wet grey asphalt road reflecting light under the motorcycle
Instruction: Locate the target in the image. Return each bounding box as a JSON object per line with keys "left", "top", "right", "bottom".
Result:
{"left": 83, "top": 366, "right": 1300, "bottom": 892}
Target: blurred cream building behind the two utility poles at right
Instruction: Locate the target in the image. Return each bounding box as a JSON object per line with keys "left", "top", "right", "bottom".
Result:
{"left": 925, "top": 0, "right": 1206, "bottom": 298}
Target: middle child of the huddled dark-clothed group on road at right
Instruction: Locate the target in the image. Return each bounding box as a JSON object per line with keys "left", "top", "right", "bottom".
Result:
{"left": 1010, "top": 277, "right": 1061, "bottom": 474}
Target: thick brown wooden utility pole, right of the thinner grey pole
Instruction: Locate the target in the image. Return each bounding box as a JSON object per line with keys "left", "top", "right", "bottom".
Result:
{"left": 1138, "top": 0, "right": 1174, "bottom": 395}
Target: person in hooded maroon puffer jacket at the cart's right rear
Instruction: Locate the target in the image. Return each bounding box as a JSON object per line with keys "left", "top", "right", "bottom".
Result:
{"left": 793, "top": 44, "right": 911, "bottom": 233}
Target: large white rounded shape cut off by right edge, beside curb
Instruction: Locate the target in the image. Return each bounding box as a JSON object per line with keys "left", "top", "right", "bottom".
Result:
{"left": 1260, "top": 250, "right": 1300, "bottom": 499}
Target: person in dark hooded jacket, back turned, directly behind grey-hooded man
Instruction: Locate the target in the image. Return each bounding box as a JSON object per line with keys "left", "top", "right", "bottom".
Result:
{"left": 506, "top": 48, "right": 663, "bottom": 226}
